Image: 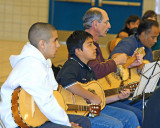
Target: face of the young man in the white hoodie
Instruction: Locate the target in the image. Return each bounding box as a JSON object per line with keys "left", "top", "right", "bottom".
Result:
{"left": 44, "top": 30, "right": 60, "bottom": 59}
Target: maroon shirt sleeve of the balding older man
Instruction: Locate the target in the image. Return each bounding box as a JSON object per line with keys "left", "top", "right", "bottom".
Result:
{"left": 88, "top": 59, "right": 117, "bottom": 79}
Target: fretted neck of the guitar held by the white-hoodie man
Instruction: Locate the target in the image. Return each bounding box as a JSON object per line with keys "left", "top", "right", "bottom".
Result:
{"left": 67, "top": 104, "right": 90, "bottom": 111}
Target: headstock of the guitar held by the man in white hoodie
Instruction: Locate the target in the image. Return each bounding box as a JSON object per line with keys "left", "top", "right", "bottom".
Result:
{"left": 89, "top": 104, "right": 101, "bottom": 117}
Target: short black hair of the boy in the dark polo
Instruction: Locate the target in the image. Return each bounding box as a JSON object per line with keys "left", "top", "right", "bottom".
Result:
{"left": 66, "top": 30, "right": 93, "bottom": 56}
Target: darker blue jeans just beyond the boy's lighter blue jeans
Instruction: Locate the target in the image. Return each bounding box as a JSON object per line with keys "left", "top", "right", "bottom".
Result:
{"left": 109, "top": 100, "right": 142, "bottom": 126}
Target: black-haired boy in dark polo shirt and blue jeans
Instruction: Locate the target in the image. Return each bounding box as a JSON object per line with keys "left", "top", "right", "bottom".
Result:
{"left": 56, "top": 30, "right": 139, "bottom": 128}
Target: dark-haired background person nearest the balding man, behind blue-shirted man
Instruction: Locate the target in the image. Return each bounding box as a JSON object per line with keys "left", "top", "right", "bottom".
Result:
{"left": 117, "top": 15, "right": 140, "bottom": 39}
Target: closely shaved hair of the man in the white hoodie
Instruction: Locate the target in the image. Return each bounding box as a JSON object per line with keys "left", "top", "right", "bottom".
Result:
{"left": 28, "top": 22, "right": 56, "bottom": 48}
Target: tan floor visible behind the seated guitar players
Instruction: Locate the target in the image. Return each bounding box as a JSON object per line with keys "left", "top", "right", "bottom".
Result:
{"left": 0, "top": 41, "right": 108, "bottom": 86}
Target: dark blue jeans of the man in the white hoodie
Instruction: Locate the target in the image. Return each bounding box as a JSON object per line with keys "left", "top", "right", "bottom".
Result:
{"left": 39, "top": 114, "right": 91, "bottom": 128}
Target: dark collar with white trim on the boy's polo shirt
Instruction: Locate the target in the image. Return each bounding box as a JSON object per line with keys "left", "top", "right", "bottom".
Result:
{"left": 70, "top": 55, "right": 92, "bottom": 71}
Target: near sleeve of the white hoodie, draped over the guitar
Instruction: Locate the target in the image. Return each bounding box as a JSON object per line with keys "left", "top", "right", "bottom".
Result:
{"left": 19, "top": 60, "right": 71, "bottom": 126}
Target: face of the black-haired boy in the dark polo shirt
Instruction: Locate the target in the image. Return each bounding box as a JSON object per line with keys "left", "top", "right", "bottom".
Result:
{"left": 79, "top": 38, "right": 96, "bottom": 64}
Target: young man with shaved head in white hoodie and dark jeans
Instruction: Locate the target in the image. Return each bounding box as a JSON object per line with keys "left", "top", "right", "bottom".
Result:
{"left": 0, "top": 22, "right": 91, "bottom": 128}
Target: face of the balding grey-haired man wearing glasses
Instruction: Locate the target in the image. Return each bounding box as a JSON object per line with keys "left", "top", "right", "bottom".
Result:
{"left": 97, "top": 11, "right": 111, "bottom": 37}
